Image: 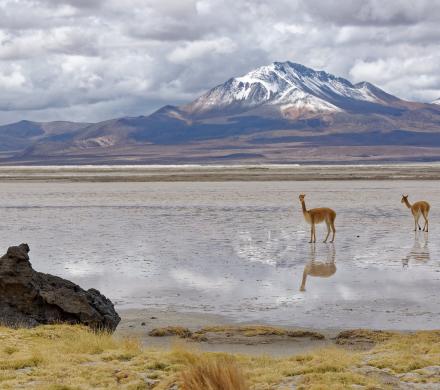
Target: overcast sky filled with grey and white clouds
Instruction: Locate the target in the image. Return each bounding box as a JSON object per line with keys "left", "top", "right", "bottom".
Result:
{"left": 0, "top": 0, "right": 440, "bottom": 123}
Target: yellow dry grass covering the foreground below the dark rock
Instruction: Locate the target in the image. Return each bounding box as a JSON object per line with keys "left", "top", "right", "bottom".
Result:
{"left": 0, "top": 325, "right": 440, "bottom": 390}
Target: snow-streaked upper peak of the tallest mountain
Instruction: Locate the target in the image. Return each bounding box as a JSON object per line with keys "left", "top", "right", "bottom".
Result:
{"left": 183, "top": 62, "right": 397, "bottom": 117}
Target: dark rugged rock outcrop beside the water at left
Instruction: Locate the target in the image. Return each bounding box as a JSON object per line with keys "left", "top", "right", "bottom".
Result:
{"left": 0, "top": 244, "right": 121, "bottom": 331}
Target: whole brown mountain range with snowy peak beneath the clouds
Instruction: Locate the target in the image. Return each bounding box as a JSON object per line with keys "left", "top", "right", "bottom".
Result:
{"left": 0, "top": 62, "right": 440, "bottom": 164}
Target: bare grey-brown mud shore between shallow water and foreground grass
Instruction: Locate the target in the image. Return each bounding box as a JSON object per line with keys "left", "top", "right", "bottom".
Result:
{"left": 114, "top": 309, "right": 420, "bottom": 358}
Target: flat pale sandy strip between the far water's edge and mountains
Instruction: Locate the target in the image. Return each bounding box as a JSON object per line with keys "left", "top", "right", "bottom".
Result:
{"left": 0, "top": 163, "right": 440, "bottom": 182}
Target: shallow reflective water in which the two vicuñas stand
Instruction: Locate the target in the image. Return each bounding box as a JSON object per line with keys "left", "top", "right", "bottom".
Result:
{"left": 0, "top": 181, "right": 440, "bottom": 329}
